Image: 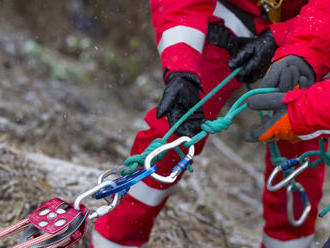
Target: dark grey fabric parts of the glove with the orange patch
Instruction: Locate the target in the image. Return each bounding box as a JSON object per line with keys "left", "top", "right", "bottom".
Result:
{"left": 244, "top": 92, "right": 288, "bottom": 142}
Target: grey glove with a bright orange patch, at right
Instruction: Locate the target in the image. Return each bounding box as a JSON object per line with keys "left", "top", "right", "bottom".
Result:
{"left": 245, "top": 92, "right": 300, "bottom": 143}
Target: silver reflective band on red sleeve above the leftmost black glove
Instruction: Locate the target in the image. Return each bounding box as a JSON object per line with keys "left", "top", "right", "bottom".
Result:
{"left": 158, "top": 26, "right": 205, "bottom": 55}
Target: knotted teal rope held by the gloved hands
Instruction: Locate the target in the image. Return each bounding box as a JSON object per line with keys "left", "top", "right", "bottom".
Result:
{"left": 122, "top": 68, "right": 330, "bottom": 186}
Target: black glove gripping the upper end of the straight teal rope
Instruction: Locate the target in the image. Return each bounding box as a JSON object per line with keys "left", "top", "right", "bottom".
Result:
{"left": 228, "top": 30, "right": 277, "bottom": 83}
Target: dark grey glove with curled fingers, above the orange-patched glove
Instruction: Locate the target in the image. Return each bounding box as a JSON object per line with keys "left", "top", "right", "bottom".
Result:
{"left": 260, "top": 55, "right": 315, "bottom": 92}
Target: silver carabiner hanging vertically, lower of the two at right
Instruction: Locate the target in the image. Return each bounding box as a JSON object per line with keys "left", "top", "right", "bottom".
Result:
{"left": 286, "top": 182, "right": 312, "bottom": 227}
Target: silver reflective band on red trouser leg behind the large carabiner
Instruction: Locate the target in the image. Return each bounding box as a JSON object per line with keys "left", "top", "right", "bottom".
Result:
{"left": 128, "top": 181, "right": 174, "bottom": 207}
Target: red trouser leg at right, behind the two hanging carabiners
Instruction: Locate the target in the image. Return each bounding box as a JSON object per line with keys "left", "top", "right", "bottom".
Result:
{"left": 262, "top": 140, "right": 325, "bottom": 241}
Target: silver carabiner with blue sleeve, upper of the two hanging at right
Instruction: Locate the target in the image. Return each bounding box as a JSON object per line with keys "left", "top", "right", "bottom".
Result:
{"left": 267, "top": 158, "right": 310, "bottom": 192}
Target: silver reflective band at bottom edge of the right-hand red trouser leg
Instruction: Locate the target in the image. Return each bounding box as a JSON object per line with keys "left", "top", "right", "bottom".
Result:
{"left": 262, "top": 233, "right": 314, "bottom": 248}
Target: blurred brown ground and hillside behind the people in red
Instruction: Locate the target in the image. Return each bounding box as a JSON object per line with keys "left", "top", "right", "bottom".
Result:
{"left": 0, "top": 0, "right": 330, "bottom": 248}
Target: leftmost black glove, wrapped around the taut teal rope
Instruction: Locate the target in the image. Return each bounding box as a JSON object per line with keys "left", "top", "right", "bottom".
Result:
{"left": 157, "top": 72, "right": 205, "bottom": 137}
